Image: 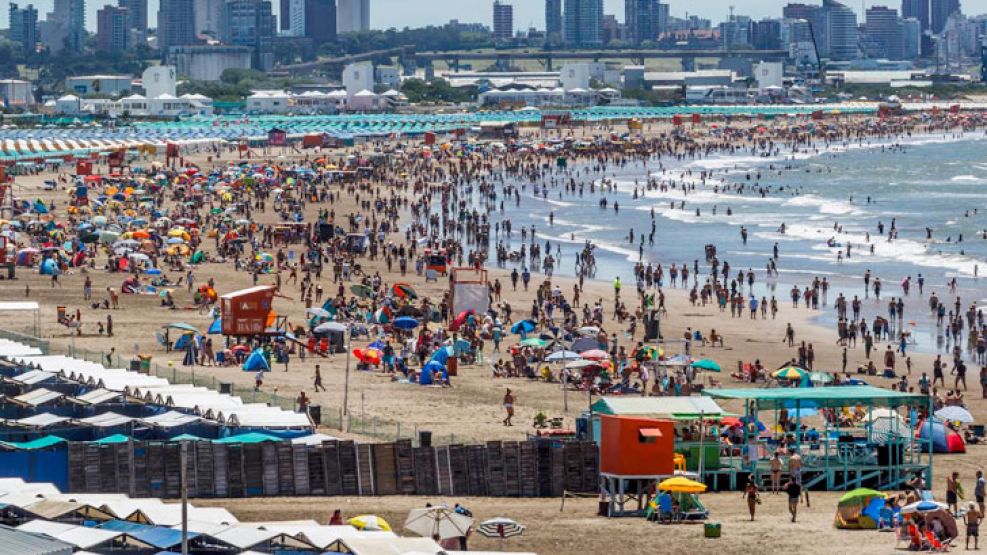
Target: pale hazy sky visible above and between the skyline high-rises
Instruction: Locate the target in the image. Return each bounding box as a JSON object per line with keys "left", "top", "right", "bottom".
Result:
{"left": 0, "top": 0, "right": 987, "bottom": 30}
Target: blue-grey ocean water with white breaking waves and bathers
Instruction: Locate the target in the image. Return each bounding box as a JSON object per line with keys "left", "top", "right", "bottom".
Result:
{"left": 476, "top": 132, "right": 987, "bottom": 351}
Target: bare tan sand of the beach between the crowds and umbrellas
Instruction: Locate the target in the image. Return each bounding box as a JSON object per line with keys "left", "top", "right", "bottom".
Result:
{"left": 0, "top": 115, "right": 987, "bottom": 554}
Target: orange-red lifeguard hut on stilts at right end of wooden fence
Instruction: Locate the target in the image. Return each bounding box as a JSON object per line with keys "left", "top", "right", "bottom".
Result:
{"left": 599, "top": 414, "right": 675, "bottom": 517}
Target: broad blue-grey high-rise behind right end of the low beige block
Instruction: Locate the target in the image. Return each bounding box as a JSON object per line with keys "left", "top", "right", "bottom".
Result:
{"left": 223, "top": 0, "right": 278, "bottom": 71}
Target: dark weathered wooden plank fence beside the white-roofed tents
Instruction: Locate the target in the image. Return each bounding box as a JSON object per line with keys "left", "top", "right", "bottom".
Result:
{"left": 68, "top": 440, "right": 599, "bottom": 498}
